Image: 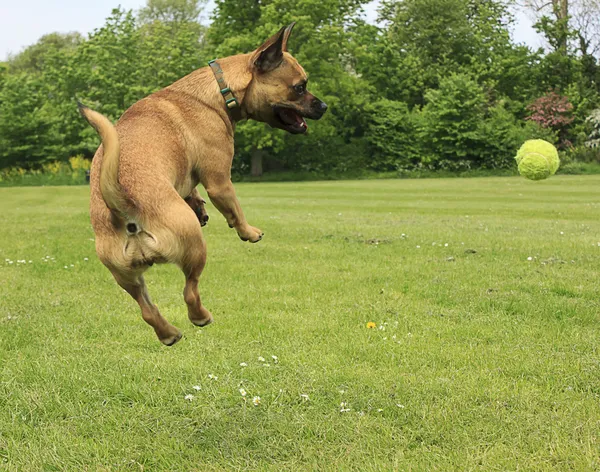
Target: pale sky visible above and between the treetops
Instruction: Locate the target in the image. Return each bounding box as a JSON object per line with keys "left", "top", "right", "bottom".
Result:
{"left": 0, "top": 0, "right": 543, "bottom": 60}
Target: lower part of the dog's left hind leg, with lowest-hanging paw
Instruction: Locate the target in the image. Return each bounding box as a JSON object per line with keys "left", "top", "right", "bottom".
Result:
{"left": 113, "top": 272, "right": 181, "bottom": 346}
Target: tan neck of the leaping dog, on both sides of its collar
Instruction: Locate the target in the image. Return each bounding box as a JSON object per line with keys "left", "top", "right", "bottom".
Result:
{"left": 167, "top": 54, "right": 252, "bottom": 124}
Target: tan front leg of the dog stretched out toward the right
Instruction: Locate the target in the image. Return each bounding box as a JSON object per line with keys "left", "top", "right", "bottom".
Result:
{"left": 206, "top": 178, "right": 263, "bottom": 243}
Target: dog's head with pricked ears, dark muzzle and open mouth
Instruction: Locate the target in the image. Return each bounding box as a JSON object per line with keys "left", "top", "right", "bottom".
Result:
{"left": 244, "top": 23, "right": 327, "bottom": 134}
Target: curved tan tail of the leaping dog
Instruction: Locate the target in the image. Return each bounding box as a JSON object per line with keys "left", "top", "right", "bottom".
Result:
{"left": 77, "top": 101, "right": 130, "bottom": 216}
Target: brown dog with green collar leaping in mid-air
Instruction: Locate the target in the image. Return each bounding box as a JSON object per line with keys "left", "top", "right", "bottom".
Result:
{"left": 80, "top": 24, "right": 327, "bottom": 346}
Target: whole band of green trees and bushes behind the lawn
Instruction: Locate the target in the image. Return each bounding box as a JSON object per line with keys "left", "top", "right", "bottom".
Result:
{"left": 0, "top": 0, "right": 600, "bottom": 176}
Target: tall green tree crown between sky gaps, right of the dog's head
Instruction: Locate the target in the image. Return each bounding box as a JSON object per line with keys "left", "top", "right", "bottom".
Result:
{"left": 376, "top": 0, "right": 536, "bottom": 107}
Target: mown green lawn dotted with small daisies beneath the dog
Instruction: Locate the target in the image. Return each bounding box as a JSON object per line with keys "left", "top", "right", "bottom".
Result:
{"left": 0, "top": 176, "right": 600, "bottom": 471}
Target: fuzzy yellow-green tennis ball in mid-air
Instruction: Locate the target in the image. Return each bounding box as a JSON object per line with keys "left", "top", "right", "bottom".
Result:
{"left": 515, "top": 139, "right": 560, "bottom": 180}
